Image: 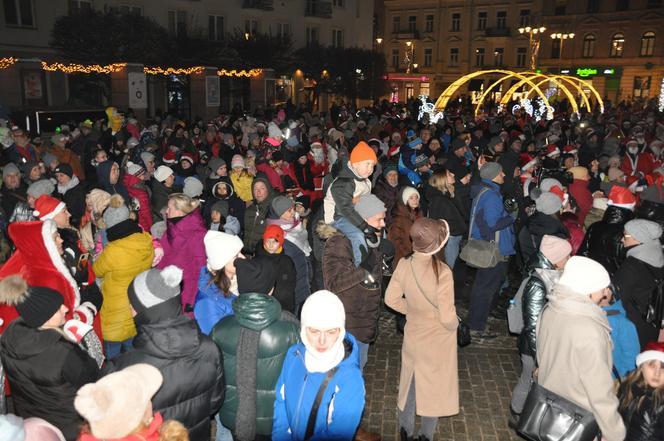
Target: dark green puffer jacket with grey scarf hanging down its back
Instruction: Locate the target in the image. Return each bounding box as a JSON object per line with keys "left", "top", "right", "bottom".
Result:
{"left": 210, "top": 293, "right": 300, "bottom": 435}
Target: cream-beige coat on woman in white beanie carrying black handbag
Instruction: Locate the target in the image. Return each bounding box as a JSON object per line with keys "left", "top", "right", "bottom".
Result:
{"left": 537, "top": 285, "right": 625, "bottom": 441}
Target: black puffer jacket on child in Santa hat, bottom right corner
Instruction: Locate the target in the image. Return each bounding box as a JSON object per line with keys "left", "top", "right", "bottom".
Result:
{"left": 618, "top": 383, "right": 664, "bottom": 441}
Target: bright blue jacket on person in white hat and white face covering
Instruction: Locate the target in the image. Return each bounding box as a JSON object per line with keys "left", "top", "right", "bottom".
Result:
{"left": 272, "top": 333, "right": 364, "bottom": 441}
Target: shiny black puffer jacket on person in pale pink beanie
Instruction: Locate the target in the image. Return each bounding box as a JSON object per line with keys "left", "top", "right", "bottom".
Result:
{"left": 517, "top": 253, "right": 559, "bottom": 358}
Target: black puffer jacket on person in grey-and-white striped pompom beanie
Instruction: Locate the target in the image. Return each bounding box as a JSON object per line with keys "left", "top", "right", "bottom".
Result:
{"left": 109, "top": 296, "right": 224, "bottom": 441}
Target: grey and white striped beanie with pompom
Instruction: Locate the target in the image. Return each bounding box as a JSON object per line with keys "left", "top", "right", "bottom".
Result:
{"left": 127, "top": 265, "right": 182, "bottom": 314}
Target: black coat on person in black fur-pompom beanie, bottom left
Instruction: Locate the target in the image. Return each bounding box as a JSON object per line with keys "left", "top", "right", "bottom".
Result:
{"left": 0, "top": 318, "right": 99, "bottom": 441}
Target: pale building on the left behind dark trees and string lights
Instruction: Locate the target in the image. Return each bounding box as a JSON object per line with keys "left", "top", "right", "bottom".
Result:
{"left": 0, "top": 0, "right": 374, "bottom": 120}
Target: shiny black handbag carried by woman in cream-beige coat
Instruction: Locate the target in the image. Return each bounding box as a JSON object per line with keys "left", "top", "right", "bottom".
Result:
{"left": 516, "top": 382, "right": 600, "bottom": 441}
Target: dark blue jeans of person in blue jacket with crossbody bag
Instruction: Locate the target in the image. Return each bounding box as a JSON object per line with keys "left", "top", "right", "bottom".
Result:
{"left": 468, "top": 262, "right": 507, "bottom": 331}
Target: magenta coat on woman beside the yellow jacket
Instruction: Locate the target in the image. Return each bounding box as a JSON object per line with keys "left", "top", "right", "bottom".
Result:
{"left": 157, "top": 208, "right": 207, "bottom": 317}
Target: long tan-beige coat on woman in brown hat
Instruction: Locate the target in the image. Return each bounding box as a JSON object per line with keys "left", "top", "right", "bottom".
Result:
{"left": 385, "top": 253, "right": 459, "bottom": 417}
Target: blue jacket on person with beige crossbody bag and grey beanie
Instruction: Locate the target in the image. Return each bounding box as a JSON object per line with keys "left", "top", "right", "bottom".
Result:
{"left": 471, "top": 179, "right": 516, "bottom": 256}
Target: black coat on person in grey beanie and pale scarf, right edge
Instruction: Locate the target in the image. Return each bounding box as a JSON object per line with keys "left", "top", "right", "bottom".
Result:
{"left": 613, "top": 256, "right": 664, "bottom": 349}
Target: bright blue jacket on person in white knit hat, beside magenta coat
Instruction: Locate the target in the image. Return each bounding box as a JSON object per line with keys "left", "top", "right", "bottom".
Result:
{"left": 194, "top": 266, "right": 236, "bottom": 335}
